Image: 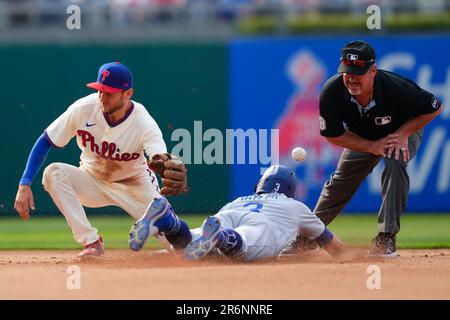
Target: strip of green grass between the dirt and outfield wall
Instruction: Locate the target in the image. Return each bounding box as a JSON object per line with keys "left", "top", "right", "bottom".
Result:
{"left": 0, "top": 214, "right": 450, "bottom": 250}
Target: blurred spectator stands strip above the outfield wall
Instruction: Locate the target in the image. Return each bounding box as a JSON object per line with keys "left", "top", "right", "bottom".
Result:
{"left": 0, "top": 0, "right": 450, "bottom": 42}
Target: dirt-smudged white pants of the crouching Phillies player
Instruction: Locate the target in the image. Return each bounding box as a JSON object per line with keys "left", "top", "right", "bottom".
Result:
{"left": 42, "top": 162, "right": 161, "bottom": 246}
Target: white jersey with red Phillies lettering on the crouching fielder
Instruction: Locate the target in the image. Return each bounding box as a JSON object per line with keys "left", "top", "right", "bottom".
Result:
{"left": 45, "top": 93, "right": 167, "bottom": 182}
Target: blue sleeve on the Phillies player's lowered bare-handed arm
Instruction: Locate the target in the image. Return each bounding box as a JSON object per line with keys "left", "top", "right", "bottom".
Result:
{"left": 19, "top": 132, "right": 53, "bottom": 185}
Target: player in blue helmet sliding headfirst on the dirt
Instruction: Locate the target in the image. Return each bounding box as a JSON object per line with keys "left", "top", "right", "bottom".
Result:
{"left": 131, "top": 165, "right": 343, "bottom": 261}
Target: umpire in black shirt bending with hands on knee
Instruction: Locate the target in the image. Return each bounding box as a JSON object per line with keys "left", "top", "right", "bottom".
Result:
{"left": 314, "top": 41, "right": 442, "bottom": 257}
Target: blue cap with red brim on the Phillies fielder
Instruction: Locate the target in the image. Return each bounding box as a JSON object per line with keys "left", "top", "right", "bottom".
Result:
{"left": 86, "top": 62, "right": 133, "bottom": 92}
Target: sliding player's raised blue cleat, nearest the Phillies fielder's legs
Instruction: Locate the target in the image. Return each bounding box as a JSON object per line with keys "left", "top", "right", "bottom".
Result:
{"left": 128, "top": 198, "right": 169, "bottom": 251}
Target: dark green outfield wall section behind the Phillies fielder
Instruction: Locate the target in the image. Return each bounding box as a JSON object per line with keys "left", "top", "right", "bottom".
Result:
{"left": 0, "top": 43, "right": 229, "bottom": 215}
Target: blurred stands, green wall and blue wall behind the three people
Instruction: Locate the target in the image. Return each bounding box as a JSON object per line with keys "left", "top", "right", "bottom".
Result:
{"left": 0, "top": 0, "right": 450, "bottom": 247}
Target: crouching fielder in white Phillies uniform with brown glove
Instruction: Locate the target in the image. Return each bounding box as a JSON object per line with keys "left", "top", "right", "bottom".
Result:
{"left": 15, "top": 62, "right": 190, "bottom": 257}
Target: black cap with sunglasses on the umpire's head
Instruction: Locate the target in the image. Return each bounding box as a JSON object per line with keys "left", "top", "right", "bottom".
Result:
{"left": 338, "top": 40, "right": 375, "bottom": 75}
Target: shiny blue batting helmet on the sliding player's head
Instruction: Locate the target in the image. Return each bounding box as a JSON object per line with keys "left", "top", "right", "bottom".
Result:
{"left": 255, "top": 165, "right": 297, "bottom": 198}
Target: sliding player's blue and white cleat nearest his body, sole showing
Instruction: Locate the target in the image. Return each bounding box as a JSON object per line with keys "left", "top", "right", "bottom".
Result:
{"left": 184, "top": 217, "right": 220, "bottom": 260}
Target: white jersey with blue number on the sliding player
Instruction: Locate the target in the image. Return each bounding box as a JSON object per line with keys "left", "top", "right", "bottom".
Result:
{"left": 219, "top": 193, "right": 325, "bottom": 247}
